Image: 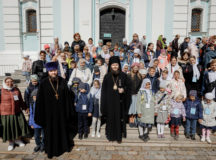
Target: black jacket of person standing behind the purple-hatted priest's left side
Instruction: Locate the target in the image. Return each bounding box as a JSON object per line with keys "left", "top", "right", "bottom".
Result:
{"left": 32, "top": 60, "right": 47, "bottom": 80}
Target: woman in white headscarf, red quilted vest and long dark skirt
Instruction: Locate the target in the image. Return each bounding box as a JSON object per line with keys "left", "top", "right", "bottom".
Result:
{"left": 0, "top": 77, "right": 30, "bottom": 151}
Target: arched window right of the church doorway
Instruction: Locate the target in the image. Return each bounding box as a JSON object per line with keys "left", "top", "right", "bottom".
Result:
{"left": 191, "top": 8, "right": 202, "bottom": 32}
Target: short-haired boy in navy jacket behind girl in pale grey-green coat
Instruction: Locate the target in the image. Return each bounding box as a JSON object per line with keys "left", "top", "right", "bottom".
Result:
{"left": 147, "top": 67, "right": 160, "bottom": 93}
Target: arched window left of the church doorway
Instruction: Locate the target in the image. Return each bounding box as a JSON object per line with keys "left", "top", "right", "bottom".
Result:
{"left": 26, "top": 9, "right": 37, "bottom": 32}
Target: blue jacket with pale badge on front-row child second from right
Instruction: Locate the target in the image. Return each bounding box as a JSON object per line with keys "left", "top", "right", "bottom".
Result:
{"left": 184, "top": 99, "right": 203, "bottom": 120}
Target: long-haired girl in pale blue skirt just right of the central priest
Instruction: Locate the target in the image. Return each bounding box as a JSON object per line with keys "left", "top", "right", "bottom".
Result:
{"left": 128, "top": 63, "right": 142, "bottom": 127}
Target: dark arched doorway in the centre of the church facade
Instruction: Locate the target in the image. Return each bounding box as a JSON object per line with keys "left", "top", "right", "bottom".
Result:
{"left": 100, "top": 7, "right": 125, "bottom": 46}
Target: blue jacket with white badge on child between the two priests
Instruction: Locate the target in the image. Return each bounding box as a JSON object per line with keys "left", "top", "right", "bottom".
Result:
{"left": 76, "top": 92, "right": 93, "bottom": 113}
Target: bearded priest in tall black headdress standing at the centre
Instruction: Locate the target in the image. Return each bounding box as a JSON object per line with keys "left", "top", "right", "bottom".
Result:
{"left": 101, "top": 56, "right": 131, "bottom": 143}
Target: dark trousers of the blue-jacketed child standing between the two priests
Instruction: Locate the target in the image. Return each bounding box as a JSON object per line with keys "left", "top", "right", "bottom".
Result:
{"left": 78, "top": 113, "right": 88, "bottom": 134}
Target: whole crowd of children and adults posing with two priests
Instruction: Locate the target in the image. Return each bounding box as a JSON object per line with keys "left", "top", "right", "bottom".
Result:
{"left": 0, "top": 33, "right": 216, "bottom": 158}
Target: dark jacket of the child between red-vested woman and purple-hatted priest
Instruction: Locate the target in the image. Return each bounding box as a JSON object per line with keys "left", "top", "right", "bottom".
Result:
{"left": 24, "top": 83, "right": 39, "bottom": 108}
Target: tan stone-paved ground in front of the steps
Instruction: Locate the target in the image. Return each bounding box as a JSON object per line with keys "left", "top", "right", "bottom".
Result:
{"left": 0, "top": 143, "right": 216, "bottom": 160}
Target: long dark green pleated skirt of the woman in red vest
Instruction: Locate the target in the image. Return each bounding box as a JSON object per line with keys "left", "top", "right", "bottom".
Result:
{"left": 1, "top": 112, "right": 30, "bottom": 142}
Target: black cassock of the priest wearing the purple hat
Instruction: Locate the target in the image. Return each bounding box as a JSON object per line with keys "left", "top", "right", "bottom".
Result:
{"left": 34, "top": 77, "right": 75, "bottom": 158}
